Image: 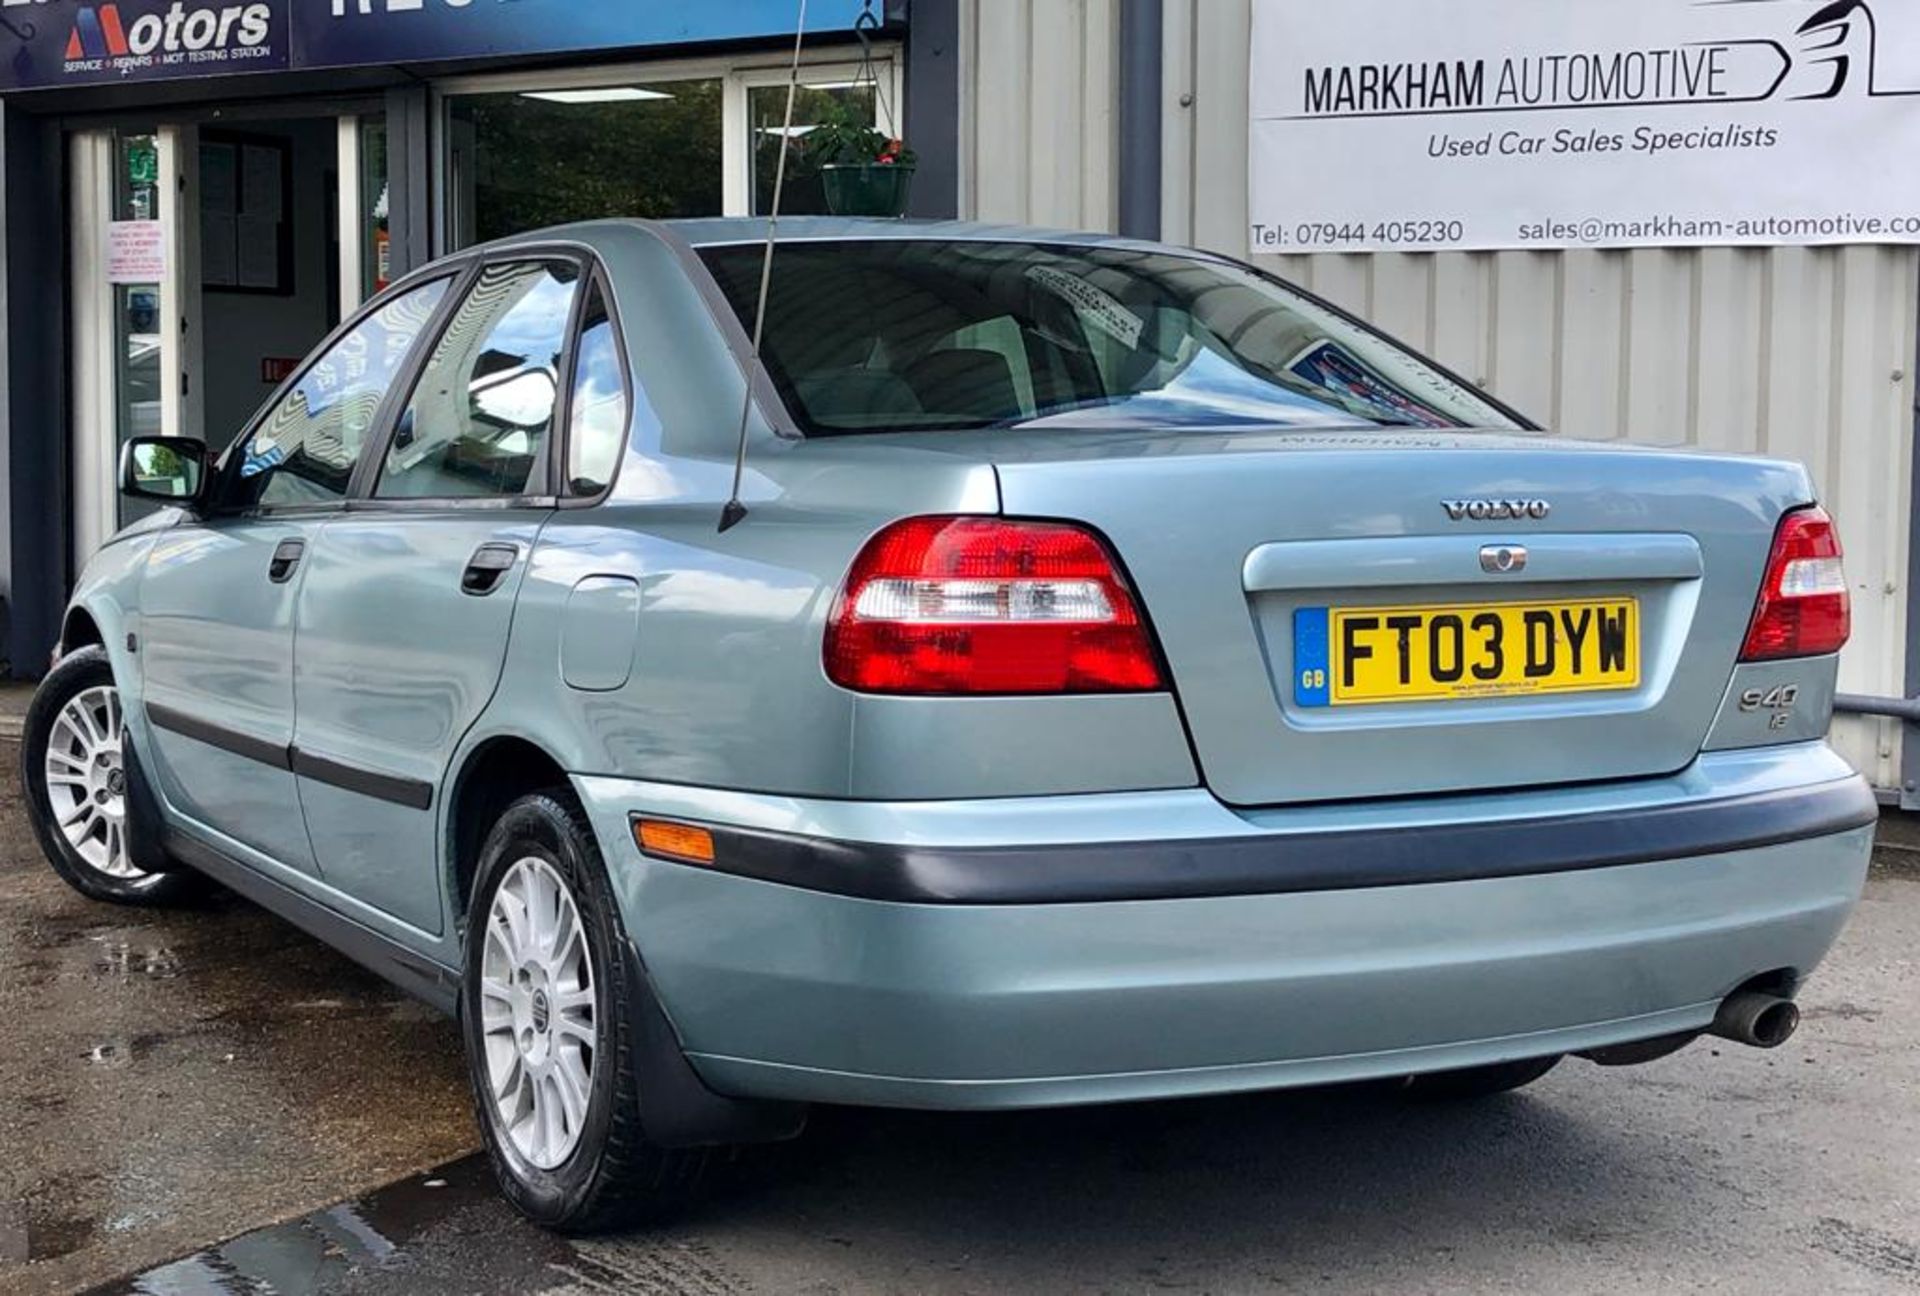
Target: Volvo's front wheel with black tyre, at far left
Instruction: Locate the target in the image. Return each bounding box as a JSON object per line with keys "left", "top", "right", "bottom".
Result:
{"left": 19, "top": 645, "right": 202, "bottom": 906}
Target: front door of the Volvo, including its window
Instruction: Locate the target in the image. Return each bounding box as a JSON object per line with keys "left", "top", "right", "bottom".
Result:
{"left": 138, "top": 280, "right": 447, "bottom": 874}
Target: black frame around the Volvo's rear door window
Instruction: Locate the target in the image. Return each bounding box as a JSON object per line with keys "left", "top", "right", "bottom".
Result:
{"left": 346, "top": 242, "right": 599, "bottom": 513}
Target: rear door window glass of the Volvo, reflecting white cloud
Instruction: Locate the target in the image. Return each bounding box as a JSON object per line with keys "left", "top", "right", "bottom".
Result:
{"left": 374, "top": 261, "right": 580, "bottom": 499}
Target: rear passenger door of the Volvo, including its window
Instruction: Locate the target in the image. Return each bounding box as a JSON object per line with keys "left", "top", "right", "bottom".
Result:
{"left": 294, "top": 257, "right": 582, "bottom": 935}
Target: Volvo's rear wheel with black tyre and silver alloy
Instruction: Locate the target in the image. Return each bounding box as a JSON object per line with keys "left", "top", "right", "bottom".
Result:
{"left": 461, "top": 791, "right": 707, "bottom": 1233}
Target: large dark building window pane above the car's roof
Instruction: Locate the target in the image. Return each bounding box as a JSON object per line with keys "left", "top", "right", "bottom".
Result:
{"left": 447, "top": 79, "right": 722, "bottom": 248}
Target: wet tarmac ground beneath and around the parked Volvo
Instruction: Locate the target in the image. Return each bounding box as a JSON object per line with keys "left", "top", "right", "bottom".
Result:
{"left": 0, "top": 729, "right": 1920, "bottom": 1296}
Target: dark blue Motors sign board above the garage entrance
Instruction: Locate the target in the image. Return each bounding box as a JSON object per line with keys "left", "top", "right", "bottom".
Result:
{"left": 0, "top": 0, "right": 883, "bottom": 90}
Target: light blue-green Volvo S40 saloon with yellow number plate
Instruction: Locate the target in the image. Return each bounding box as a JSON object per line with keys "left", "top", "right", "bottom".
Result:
{"left": 25, "top": 221, "right": 1876, "bottom": 1229}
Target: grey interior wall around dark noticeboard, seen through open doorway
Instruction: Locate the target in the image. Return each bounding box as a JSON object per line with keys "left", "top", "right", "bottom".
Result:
{"left": 198, "top": 119, "right": 338, "bottom": 447}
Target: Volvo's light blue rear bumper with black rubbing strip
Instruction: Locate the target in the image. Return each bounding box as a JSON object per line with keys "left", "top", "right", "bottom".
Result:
{"left": 576, "top": 745, "right": 1874, "bottom": 1108}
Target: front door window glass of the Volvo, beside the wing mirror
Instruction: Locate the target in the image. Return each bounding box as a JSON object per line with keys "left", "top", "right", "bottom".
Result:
{"left": 228, "top": 278, "right": 449, "bottom": 507}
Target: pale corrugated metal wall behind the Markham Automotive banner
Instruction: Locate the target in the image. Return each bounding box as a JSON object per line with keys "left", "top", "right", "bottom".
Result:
{"left": 962, "top": 0, "right": 1920, "bottom": 787}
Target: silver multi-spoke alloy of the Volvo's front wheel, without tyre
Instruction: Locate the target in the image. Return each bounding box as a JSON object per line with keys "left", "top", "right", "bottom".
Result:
{"left": 42, "top": 685, "right": 150, "bottom": 881}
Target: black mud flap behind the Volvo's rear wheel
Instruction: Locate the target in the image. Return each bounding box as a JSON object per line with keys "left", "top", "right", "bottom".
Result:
{"left": 626, "top": 941, "right": 806, "bottom": 1148}
